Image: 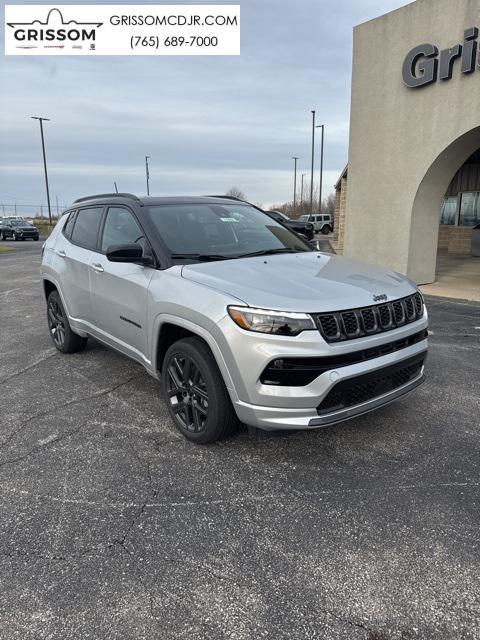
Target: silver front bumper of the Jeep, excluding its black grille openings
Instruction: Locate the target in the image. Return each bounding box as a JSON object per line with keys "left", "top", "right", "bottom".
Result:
{"left": 214, "top": 312, "right": 428, "bottom": 430}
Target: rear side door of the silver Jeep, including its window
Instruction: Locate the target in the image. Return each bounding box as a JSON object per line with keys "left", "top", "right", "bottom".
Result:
{"left": 54, "top": 206, "right": 104, "bottom": 325}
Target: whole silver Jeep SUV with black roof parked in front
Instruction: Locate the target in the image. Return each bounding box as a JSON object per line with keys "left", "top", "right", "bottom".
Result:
{"left": 42, "top": 194, "right": 427, "bottom": 442}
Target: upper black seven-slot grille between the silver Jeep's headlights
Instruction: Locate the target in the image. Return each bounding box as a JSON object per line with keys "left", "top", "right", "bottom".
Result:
{"left": 314, "top": 293, "right": 423, "bottom": 342}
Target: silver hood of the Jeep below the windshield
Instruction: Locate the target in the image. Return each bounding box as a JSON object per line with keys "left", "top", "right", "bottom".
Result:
{"left": 182, "top": 252, "right": 416, "bottom": 312}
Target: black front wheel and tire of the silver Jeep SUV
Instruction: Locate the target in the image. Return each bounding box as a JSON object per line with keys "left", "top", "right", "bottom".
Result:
{"left": 162, "top": 337, "right": 238, "bottom": 444}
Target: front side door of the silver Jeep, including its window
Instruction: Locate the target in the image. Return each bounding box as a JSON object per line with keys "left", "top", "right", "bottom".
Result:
{"left": 90, "top": 205, "right": 154, "bottom": 360}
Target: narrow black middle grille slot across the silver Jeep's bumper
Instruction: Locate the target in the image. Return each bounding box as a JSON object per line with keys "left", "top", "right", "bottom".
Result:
{"left": 260, "top": 329, "right": 428, "bottom": 387}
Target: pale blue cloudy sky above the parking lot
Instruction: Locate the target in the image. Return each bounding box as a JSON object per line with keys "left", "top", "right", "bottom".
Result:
{"left": 0, "top": 0, "right": 408, "bottom": 215}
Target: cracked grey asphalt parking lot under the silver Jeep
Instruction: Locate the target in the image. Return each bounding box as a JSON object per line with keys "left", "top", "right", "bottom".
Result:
{"left": 0, "top": 242, "right": 480, "bottom": 640}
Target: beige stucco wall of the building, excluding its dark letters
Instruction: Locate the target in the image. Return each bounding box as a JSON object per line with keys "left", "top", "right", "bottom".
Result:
{"left": 345, "top": 0, "right": 480, "bottom": 283}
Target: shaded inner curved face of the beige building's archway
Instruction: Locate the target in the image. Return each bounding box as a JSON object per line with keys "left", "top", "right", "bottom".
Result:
{"left": 408, "top": 126, "right": 480, "bottom": 286}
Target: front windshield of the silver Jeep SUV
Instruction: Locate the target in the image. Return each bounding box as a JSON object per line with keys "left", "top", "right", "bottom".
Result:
{"left": 148, "top": 204, "right": 312, "bottom": 260}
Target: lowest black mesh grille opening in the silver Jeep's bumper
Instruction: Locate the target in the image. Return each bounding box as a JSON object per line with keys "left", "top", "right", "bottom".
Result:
{"left": 317, "top": 352, "right": 426, "bottom": 415}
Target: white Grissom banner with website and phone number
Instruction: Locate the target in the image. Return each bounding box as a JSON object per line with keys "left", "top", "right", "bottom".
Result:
{"left": 5, "top": 4, "right": 240, "bottom": 56}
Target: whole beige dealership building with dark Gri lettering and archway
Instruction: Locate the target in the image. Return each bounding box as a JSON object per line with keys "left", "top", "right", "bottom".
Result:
{"left": 335, "top": 0, "right": 480, "bottom": 290}
